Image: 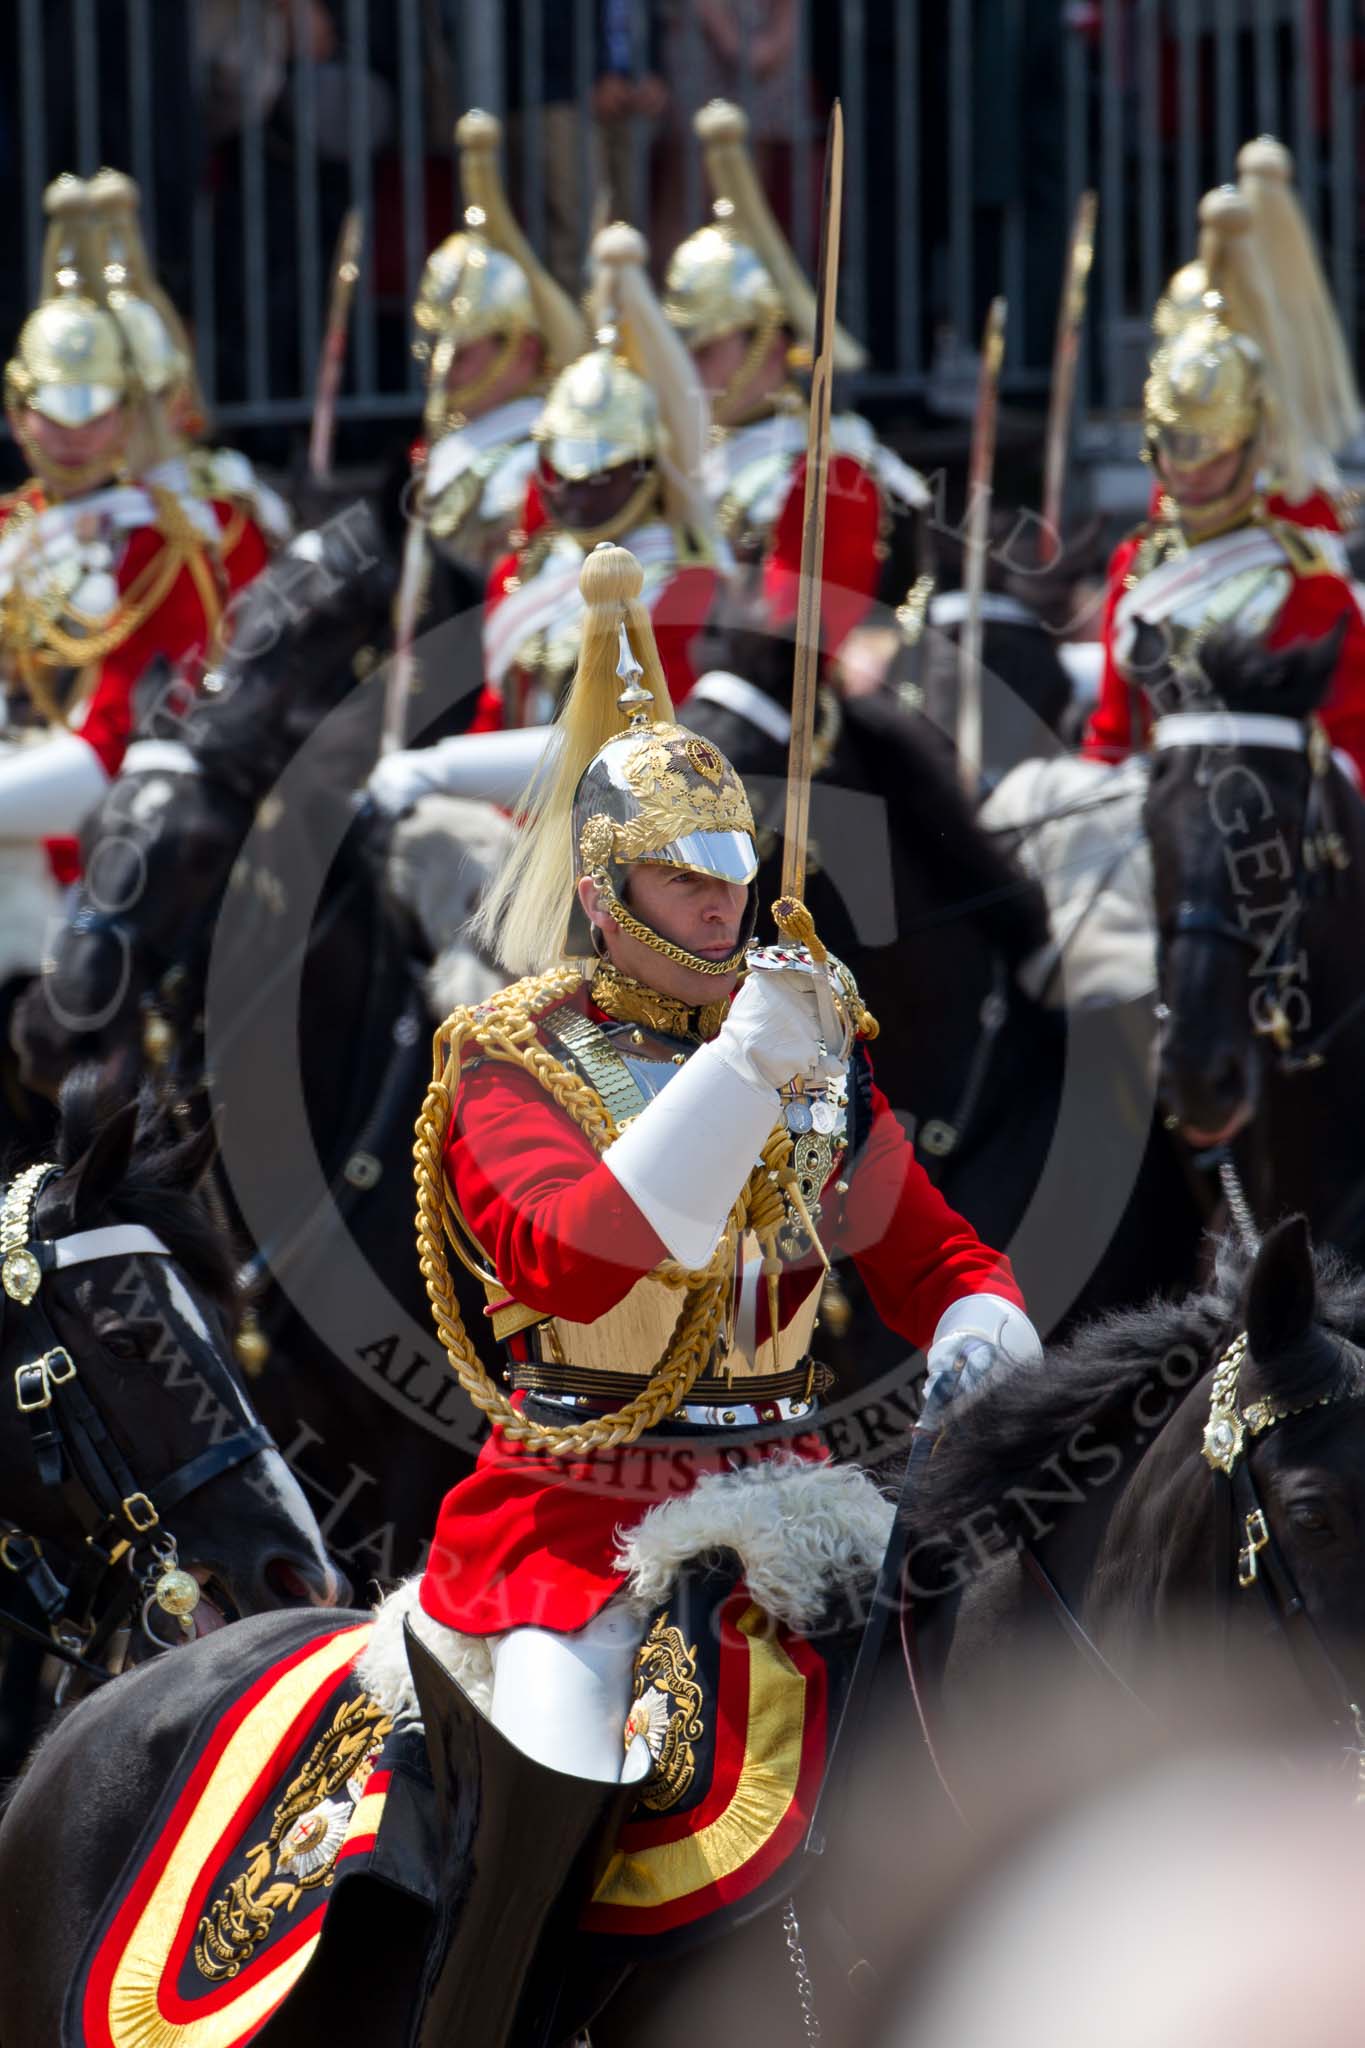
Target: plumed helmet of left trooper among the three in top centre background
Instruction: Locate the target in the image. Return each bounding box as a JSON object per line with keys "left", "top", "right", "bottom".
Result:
{"left": 413, "top": 106, "right": 589, "bottom": 432}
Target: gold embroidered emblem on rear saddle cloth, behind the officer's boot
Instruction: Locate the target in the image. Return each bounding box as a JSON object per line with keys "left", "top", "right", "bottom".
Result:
{"left": 194, "top": 1694, "right": 393, "bottom": 1982}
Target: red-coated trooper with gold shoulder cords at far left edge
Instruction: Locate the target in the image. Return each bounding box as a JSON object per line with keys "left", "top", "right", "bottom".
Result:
{"left": 0, "top": 176, "right": 266, "bottom": 921}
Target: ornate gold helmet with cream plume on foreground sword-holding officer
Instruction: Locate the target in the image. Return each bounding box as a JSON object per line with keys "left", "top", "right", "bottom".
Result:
{"left": 479, "top": 543, "right": 759, "bottom": 977}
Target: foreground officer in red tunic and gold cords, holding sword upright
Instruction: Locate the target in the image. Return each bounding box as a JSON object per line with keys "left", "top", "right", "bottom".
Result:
{"left": 397, "top": 545, "right": 1040, "bottom": 1974}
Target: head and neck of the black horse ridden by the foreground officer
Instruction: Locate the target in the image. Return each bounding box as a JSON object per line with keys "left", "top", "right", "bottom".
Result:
{"left": 907, "top": 1217, "right": 1365, "bottom": 1769}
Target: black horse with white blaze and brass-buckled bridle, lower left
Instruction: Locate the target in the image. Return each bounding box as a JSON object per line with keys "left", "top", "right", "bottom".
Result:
{"left": 0, "top": 1067, "right": 344, "bottom": 1776}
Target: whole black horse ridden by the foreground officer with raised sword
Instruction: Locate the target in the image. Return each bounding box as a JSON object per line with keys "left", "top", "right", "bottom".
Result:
{"left": 0, "top": 1221, "right": 1365, "bottom": 2048}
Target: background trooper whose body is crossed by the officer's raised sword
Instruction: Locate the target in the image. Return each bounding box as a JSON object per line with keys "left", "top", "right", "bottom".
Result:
{"left": 663, "top": 100, "right": 929, "bottom": 653}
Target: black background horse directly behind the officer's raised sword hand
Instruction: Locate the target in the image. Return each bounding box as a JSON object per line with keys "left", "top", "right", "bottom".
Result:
{"left": 681, "top": 593, "right": 1201, "bottom": 1350}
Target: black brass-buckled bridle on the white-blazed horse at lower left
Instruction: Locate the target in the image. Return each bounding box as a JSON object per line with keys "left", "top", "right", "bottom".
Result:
{"left": 0, "top": 1165, "right": 272, "bottom": 1679}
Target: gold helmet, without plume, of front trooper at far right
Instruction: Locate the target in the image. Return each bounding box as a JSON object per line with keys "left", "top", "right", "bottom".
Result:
{"left": 1144, "top": 307, "right": 1265, "bottom": 471}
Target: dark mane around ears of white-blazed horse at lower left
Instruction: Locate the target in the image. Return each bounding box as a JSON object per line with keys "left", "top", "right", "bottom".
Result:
{"left": 37, "top": 1063, "right": 239, "bottom": 1313}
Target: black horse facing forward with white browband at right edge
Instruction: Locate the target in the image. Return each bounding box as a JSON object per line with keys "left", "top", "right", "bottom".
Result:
{"left": 1146, "top": 633, "right": 1365, "bottom": 1257}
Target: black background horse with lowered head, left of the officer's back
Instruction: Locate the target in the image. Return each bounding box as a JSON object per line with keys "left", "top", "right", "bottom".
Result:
{"left": 20, "top": 520, "right": 497, "bottom": 1583}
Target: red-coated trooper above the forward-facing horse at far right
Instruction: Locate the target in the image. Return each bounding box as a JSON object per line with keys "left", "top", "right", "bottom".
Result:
{"left": 1085, "top": 155, "right": 1365, "bottom": 782}
